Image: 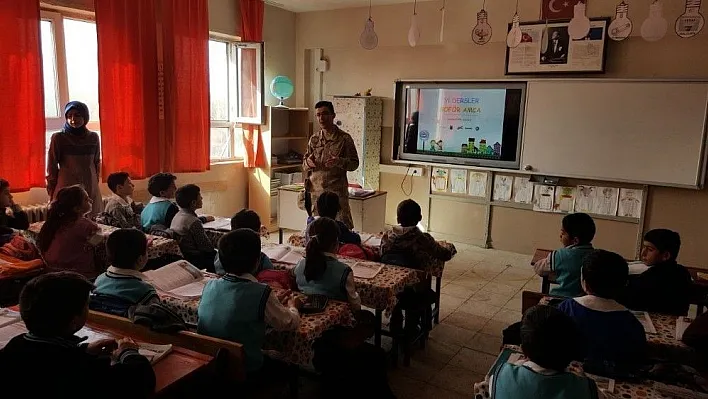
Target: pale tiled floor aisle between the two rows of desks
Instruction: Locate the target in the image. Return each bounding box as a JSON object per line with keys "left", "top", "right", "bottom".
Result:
{"left": 271, "top": 234, "right": 541, "bottom": 399}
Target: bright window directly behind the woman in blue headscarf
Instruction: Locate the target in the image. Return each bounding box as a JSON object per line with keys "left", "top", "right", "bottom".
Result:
{"left": 40, "top": 11, "right": 101, "bottom": 156}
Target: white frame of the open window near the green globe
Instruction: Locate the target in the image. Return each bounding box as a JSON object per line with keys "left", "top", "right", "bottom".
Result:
{"left": 209, "top": 32, "right": 265, "bottom": 164}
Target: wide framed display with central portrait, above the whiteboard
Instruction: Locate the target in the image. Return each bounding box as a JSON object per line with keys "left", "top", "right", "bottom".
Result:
{"left": 505, "top": 18, "right": 610, "bottom": 75}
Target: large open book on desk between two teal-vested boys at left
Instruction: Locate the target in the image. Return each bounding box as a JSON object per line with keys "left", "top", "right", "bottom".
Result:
{"left": 143, "top": 260, "right": 207, "bottom": 299}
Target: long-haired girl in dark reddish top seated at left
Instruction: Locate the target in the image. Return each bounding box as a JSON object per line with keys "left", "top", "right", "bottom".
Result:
{"left": 37, "top": 185, "right": 103, "bottom": 280}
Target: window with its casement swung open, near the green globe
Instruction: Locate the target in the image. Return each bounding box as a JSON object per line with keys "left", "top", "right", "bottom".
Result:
{"left": 209, "top": 39, "right": 263, "bottom": 161}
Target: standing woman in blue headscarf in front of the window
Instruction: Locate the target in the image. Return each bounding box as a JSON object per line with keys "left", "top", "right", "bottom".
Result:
{"left": 47, "top": 101, "right": 103, "bottom": 216}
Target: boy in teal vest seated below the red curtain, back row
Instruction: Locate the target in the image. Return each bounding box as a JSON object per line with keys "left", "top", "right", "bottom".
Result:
{"left": 140, "top": 173, "right": 179, "bottom": 232}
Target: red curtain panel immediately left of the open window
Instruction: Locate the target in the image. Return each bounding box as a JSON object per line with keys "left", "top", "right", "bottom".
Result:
{"left": 162, "top": 0, "right": 210, "bottom": 172}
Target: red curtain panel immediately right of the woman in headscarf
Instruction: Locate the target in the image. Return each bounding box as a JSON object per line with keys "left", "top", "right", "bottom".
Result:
{"left": 95, "top": 0, "right": 161, "bottom": 180}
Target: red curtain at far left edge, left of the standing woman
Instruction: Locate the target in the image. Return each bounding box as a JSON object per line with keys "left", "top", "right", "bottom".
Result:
{"left": 0, "top": 0, "right": 45, "bottom": 191}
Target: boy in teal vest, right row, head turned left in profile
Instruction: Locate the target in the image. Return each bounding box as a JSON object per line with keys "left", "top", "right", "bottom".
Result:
{"left": 534, "top": 213, "right": 595, "bottom": 297}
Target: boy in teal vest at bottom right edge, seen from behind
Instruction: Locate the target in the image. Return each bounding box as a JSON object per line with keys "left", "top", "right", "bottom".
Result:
{"left": 489, "top": 305, "right": 605, "bottom": 399}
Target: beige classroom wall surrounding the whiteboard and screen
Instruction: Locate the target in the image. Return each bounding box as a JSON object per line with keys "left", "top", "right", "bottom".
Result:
{"left": 296, "top": 0, "right": 708, "bottom": 267}
